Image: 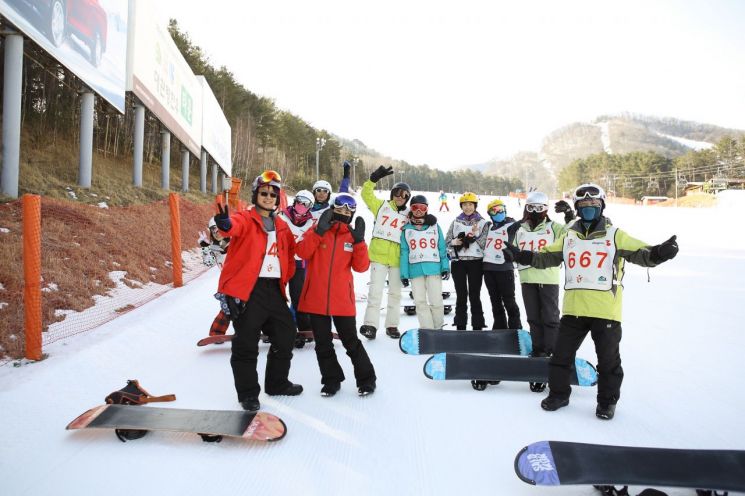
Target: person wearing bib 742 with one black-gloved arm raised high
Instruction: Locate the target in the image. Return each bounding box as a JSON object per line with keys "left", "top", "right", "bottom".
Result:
{"left": 360, "top": 165, "right": 411, "bottom": 339}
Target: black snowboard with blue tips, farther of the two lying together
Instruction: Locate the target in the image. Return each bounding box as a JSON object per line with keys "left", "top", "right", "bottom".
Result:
{"left": 398, "top": 329, "right": 533, "bottom": 355}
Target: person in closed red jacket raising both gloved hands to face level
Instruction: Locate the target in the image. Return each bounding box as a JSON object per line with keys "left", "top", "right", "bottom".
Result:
{"left": 297, "top": 194, "right": 376, "bottom": 396}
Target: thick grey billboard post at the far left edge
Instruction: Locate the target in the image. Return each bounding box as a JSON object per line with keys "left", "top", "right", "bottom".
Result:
{"left": 0, "top": 31, "right": 23, "bottom": 198}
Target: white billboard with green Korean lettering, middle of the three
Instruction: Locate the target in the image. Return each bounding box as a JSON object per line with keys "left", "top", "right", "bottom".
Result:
{"left": 127, "top": 0, "right": 202, "bottom": 156}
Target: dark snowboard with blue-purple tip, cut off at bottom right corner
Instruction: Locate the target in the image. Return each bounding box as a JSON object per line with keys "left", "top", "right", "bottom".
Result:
{"left": 515, "top": 441, "right": 745, "bottom": 491}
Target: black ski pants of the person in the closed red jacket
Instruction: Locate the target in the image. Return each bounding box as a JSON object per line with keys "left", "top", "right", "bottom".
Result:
{"left": 310, "top": 313, "right": 376, "bottom": 387}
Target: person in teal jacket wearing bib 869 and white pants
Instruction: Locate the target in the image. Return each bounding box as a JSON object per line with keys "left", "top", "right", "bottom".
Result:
{"left": 401, "top": 195, "right": 450, "bottom": 329}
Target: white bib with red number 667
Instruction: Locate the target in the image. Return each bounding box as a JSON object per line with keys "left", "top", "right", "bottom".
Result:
{"left": 563, "top": 227, "right": 616, "bottom": 291}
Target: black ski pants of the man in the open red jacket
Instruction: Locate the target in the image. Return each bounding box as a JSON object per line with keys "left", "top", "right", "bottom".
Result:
{"left": 230, "top": 277, "right": 297, "bottom": 402}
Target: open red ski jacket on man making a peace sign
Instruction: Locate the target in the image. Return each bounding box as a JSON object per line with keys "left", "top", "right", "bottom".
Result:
{"left": 217, "top": 208, "right": 295, "bottom": 301}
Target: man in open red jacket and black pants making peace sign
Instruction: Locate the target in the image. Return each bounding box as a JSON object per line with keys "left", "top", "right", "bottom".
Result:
{"left": 215, "top": 170, "right": 303, "bottom": 411}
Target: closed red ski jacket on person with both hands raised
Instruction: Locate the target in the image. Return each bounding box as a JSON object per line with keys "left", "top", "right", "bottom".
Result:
{"left": 294, "top": 223, "right": 370, "bottom": 317}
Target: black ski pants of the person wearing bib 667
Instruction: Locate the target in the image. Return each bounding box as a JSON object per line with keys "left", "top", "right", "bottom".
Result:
{"left": 548, "top": 315, "right": 623, "bottom": 405}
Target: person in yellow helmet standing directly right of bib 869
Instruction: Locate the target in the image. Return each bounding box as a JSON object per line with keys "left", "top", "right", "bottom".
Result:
{"left": 445, "top": 191, "right": 489, "bottom": 331}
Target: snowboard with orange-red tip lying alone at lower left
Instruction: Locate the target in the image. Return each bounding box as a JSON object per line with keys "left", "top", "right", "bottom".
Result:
{"left": 67, "top": 405, "right": 287, "bottom": 441}
